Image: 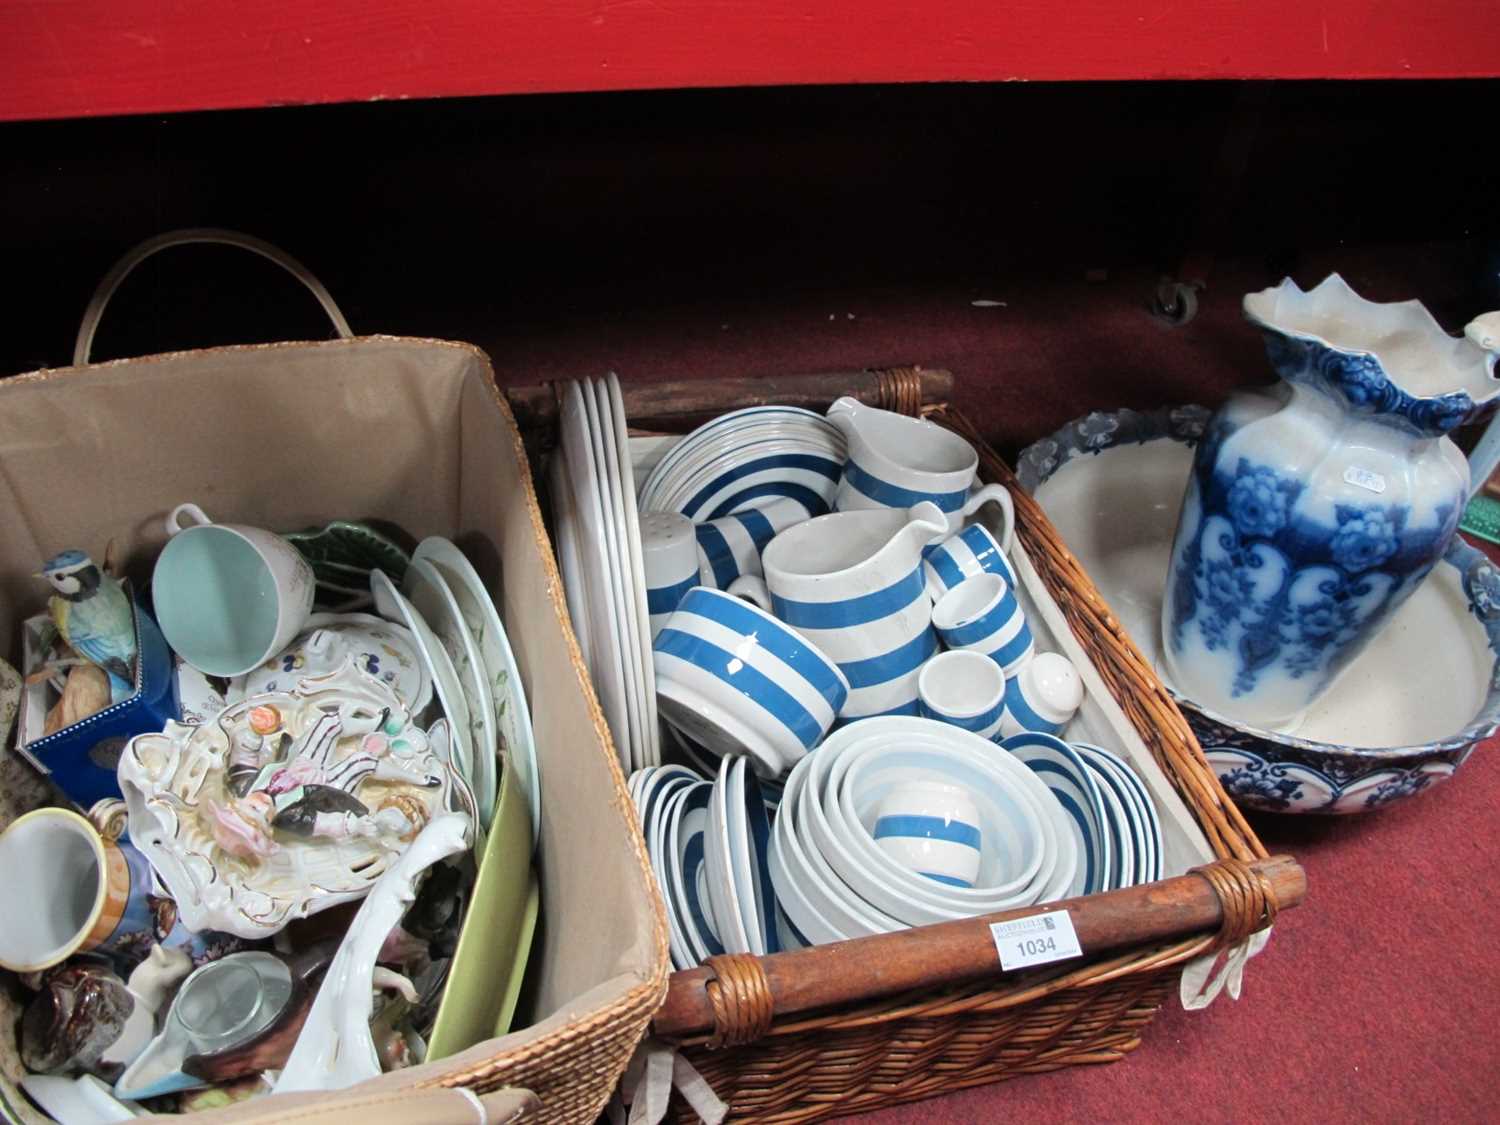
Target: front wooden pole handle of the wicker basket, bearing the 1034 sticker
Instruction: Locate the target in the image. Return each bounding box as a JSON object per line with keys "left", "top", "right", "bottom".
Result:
{"left": 651, "top": 855, "right": 1307, "bottom": 1046}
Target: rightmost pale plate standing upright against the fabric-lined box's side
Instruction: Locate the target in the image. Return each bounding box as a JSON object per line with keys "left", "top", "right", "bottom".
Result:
{"left": 413, "top": 536, "right": 542, "bottom": 848}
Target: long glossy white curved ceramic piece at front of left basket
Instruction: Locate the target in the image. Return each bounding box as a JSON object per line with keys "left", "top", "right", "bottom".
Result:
{"left": 276, "top": 815, "right": 470, "bottom": 1094}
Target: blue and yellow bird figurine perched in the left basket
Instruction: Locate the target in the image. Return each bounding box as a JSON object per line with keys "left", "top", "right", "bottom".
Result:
{"left": 38, "top": 551, "right": 135, "bottom": 704}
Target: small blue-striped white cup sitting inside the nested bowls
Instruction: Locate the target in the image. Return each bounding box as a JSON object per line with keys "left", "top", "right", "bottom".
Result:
{"left": 872, "top": 780, "right": 981, "bottom": 887}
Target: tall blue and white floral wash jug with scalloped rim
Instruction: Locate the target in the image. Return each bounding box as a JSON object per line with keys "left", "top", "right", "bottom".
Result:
{"left": 1161, "top": 273, "right": 1500, "bottom": 729}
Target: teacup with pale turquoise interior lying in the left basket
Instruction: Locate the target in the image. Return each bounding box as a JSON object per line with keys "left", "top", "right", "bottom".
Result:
{"left": 152, "top": 504, "right": 314, "bottom": 678}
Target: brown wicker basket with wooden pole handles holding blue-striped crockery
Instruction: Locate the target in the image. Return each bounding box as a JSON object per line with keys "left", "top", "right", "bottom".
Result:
{"left": 512, "top": 368, "right": 1305, "bottom": 1122}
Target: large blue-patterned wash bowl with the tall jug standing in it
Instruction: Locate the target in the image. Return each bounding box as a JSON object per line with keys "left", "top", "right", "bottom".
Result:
{"left": 1017, "top": 407, "right": 1500, "bottom": 813}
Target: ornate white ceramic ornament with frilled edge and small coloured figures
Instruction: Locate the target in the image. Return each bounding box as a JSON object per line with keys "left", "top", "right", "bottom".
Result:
{"left": 119, "top": 663, "right": 470, "bottom": 939}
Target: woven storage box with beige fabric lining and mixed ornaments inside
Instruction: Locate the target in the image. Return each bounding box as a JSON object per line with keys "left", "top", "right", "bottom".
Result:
{"left": 0, "top": 288, "right": 666, "bottom": 1122}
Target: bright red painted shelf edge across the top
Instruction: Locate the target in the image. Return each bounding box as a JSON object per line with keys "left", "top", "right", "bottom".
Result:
{"left": 0, "top": 0, "right": 1500, "bottom": 120}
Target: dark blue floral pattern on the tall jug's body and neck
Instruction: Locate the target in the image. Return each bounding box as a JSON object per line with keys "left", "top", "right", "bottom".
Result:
{"left": 1158, "top": 329, "right": 1473, "bottom": 701}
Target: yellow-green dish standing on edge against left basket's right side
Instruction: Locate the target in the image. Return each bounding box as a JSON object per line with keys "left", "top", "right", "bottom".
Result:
{"left": 428, "top": 762, "right": 540, "bottom": 1061}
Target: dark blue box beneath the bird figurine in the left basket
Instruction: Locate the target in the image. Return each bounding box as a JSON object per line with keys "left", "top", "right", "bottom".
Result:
{"left": 17, "top": 597, "right": 182, "bottom": 809}
